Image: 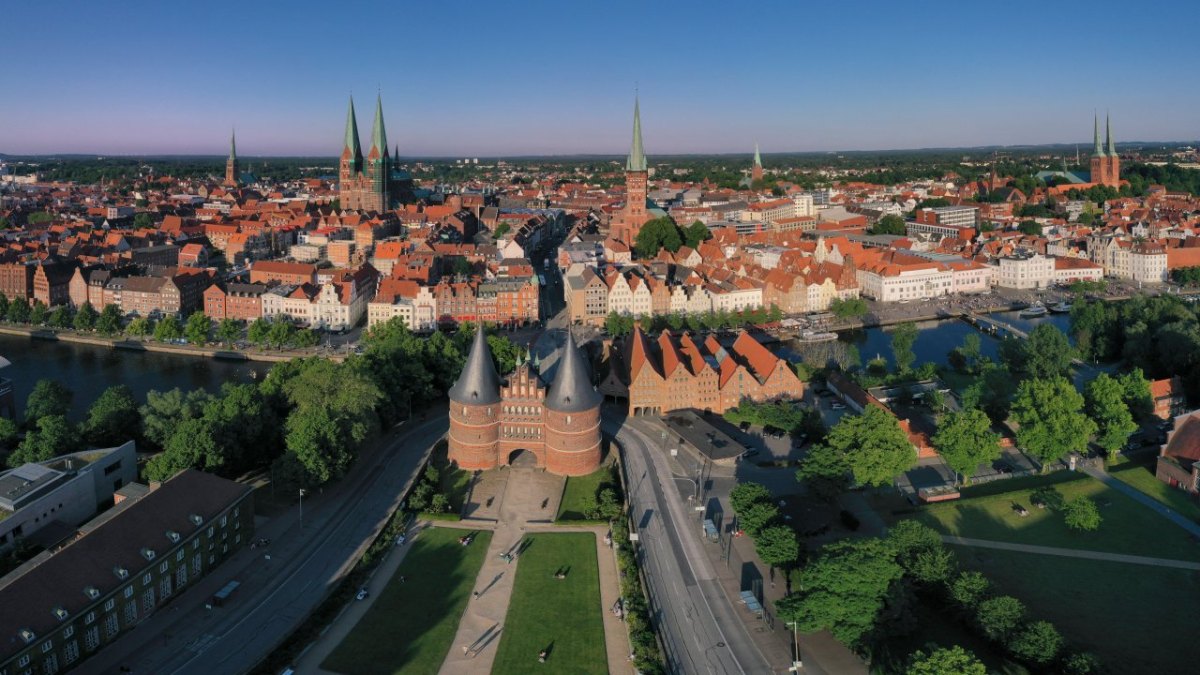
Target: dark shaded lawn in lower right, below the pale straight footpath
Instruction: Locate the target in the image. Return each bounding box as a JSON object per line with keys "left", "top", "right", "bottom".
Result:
{"left": 953, "top": 546, "right": 1200, "bottom": 675}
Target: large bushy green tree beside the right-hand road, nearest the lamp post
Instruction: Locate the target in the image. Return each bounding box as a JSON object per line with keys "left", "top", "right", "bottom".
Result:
{"left": 775, "top": 539, "right": 904, "bottom": 647}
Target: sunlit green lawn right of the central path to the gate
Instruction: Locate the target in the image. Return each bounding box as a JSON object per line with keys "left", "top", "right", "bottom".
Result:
{"left": 492, "top": 532, "right": 608, "bottom": 675}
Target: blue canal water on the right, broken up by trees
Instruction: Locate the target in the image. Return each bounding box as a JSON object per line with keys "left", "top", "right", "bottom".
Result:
{"left": 780, "top": 311, "right": 1070, "bottom": 366}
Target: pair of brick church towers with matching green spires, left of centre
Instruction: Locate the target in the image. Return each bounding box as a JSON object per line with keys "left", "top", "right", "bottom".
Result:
{"left": 337, "top": 97, "right": 392, "bottom": 213}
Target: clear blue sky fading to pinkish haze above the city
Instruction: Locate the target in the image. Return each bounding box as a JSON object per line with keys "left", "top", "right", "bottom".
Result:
{"left": 0, "top": 0, "right": 1200, "bottom": 157}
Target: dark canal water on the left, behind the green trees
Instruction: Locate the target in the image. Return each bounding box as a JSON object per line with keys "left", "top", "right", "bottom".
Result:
{"left": 0, "top": 335, "right": 261, "bottom": 422}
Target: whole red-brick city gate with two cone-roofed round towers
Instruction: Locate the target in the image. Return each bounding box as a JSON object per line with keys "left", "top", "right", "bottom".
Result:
{"left": 449, "top": 328, "right": 602, "bottom": 476}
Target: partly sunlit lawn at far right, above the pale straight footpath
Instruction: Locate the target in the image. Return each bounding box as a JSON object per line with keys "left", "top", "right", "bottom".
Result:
{"left": 916, "top": 477, "right": 1200, "bottom": 560}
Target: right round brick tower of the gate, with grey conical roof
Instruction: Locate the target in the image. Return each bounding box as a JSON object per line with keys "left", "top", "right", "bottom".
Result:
{"left": 544, "top": 329, "right": 604, "bottom": 476}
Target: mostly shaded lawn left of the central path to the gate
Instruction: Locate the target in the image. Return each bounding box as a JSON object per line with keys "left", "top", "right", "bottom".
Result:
{"left": 320, "top": 527, "right": 492, "bottom": 675}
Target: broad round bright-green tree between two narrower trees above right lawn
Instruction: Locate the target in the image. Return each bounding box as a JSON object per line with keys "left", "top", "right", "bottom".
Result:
{"left": 1013, "top": 377, "right": 1096, "bottom": 472}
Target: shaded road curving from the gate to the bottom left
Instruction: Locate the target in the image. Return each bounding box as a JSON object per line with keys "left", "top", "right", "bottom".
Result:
{"left": 78, "top": 414, "right": 448, "bottom": 675}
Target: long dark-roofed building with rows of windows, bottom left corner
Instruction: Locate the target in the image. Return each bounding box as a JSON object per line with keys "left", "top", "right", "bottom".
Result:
{"left": 0, "top": 470, "right": 254, "bottom": 675}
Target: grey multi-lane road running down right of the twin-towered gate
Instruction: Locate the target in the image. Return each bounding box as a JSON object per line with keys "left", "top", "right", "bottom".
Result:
{"left": 604, "top": 414, "right": 770, "bottom": 674}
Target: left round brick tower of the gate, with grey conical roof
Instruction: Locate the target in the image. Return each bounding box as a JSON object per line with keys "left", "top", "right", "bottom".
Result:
{"left": 449, "top": 325, "right": 500, "bottom": 471}
